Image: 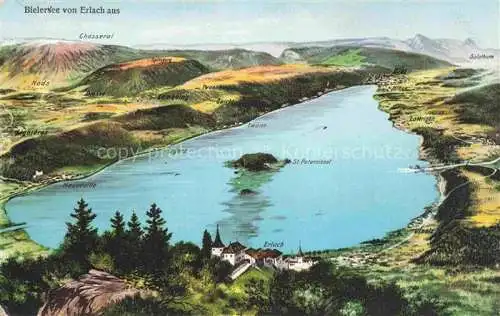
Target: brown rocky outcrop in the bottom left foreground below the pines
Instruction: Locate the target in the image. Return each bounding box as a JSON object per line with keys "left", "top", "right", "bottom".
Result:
{"left": 38, "top": 270, "right": 141, "bottom": 316}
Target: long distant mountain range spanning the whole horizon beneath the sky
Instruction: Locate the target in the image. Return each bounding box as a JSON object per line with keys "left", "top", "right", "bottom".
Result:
{"left": 0, "top": 34, "right": 492, "bottom": 95}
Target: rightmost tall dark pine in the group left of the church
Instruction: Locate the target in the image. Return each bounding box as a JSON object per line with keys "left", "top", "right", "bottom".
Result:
{"left": 143, "top": 204, "right": 172, "bottom": 274}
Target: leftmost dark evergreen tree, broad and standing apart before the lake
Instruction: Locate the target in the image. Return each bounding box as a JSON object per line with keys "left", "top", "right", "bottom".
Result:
{"left": 62, "top": 198, "right": 98, "bottom": 265}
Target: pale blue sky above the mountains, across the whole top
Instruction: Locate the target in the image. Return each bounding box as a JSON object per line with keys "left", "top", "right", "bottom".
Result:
{"left": 0, "top": 0, "right": 500, "bottom": 48}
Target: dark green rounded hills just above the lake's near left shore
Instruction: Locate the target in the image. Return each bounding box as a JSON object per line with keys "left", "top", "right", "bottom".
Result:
{"left": 0, "top": 104, "right": 215, "bottom": 180}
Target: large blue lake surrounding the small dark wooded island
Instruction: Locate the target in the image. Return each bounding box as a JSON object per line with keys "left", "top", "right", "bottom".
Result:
{"left": 6, "top": 86, "right": 438, "bottom": 252}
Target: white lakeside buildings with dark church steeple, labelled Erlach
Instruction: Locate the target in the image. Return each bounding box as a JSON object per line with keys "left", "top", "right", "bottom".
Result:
{"left": 212, "top": 226, "right": 317, "bottom": 271}
